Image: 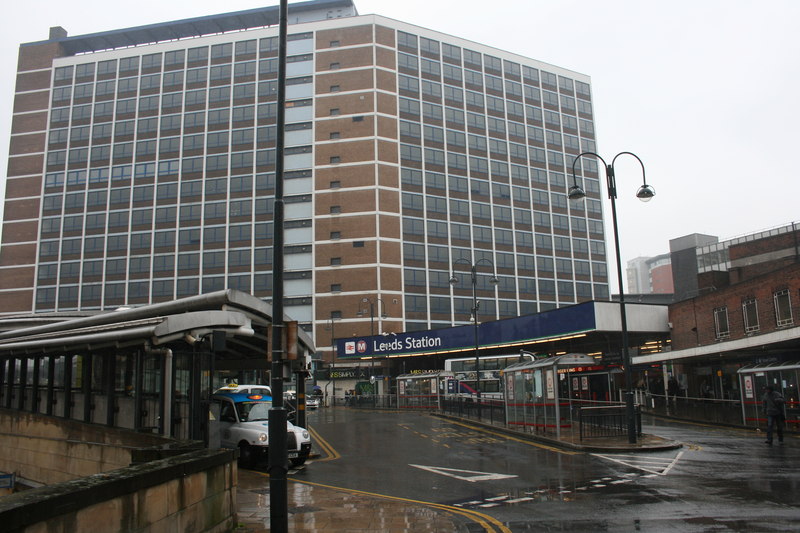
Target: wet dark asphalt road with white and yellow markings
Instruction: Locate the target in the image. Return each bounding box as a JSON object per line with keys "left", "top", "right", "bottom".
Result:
{"left": 240, "top": 408, "right": 800, "bottom": 532}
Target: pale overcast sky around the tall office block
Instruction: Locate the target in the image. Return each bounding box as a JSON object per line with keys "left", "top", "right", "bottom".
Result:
{"left": 0, "top": 0, "right": 800, "bottom": 290}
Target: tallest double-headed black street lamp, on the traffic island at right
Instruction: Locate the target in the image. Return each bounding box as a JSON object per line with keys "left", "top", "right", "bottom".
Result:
{"left": 568, "top": 152, "right": 656, "bottom": 444}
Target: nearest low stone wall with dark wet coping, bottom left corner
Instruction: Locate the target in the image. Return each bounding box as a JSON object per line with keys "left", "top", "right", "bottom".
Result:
{"left": 0, "top": 450, "right": 237, "bottom": 533}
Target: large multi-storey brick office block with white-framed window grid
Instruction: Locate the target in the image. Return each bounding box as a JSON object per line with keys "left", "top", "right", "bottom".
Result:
{"left": 0, "top": 0, "right": 608, "bottom": 366}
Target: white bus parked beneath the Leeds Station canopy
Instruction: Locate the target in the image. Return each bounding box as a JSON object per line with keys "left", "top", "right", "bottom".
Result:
{"left": 444, "top": 352, "right": 534, "bottom": 399}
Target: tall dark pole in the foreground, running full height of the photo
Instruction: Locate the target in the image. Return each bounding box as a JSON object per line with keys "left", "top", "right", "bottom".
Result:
{"left": 268, "top": 0, "right": 289, "bottom": 533}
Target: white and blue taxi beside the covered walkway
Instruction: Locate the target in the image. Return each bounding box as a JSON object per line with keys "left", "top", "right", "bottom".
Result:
{"left": 211, "top": 392, "right": 311, "bottom": 468}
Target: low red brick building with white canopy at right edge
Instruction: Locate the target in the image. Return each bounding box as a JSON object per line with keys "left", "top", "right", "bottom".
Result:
{"left": 634, "top": 224, "right": 800, "bottom": 401}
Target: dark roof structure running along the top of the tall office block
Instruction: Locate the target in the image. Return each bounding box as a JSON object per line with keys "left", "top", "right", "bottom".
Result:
{"left": 22, "top": 0, "right": 357, "bottom": 55}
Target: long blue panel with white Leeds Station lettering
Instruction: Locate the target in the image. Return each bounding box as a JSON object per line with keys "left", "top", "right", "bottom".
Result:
{"left": 336, "top": 302, "right": 595, "bottom": 359}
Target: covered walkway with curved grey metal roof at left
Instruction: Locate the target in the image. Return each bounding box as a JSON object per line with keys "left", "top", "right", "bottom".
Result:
{"left": 0, "top": 290, "right": 314, "bottom": 441}
